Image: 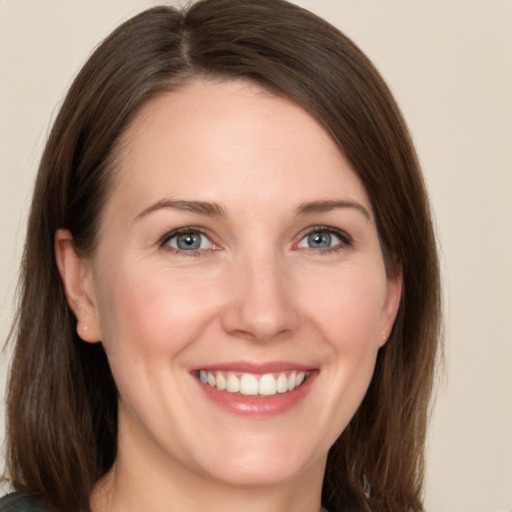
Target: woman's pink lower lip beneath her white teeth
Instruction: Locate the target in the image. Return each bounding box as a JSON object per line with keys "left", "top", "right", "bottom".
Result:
{"left": 196, "top": 371, "right": 318, "bottom": 417}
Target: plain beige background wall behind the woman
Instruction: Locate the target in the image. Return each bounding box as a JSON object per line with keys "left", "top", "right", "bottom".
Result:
{"left": 0, "top": 0, "right": 512, "bottom": 512}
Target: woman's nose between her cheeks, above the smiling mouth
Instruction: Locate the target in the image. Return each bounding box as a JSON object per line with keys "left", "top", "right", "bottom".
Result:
{"left": 222, "top": 250, "right": 299, "bottom": 342}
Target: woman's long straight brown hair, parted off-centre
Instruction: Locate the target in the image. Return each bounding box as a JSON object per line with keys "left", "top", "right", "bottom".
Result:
{"left": 7, "top": 0, "right": 440, "bottom": 512}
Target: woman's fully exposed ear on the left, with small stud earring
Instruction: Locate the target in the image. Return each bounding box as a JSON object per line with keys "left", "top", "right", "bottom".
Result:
{"left": 55, "top": 229, "right": 101, "bottom": 343}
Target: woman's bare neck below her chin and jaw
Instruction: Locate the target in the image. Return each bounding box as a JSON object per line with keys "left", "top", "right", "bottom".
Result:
{"left": 91, "top": 426, "right": 325, "bottom": 512}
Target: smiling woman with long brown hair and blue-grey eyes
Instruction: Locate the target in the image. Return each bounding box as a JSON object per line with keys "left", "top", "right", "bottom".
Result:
{"left": 3, "top": 0, "right": 439, "bottom": 512}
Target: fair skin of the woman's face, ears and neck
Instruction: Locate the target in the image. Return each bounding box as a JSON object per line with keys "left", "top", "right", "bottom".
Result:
{"left": 56, "top": 82, "right": 401, "bottom": 512}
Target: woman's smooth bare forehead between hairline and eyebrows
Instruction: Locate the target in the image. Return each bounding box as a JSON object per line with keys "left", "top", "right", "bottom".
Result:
{"left": 108, "top": 81, "right": 369, "bottom": 216}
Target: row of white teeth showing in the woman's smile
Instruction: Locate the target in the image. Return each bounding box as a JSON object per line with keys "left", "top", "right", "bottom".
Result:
{"left": 197, "top": 370, "right": 309, "bottom": 396}
